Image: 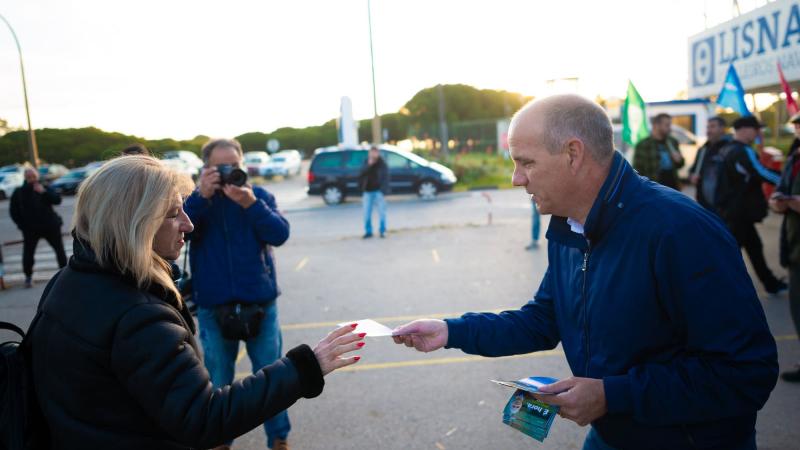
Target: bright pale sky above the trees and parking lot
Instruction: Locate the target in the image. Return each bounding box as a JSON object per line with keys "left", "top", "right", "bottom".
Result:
{"left": 0, "top": 0, "right": 766, "bottom": 139}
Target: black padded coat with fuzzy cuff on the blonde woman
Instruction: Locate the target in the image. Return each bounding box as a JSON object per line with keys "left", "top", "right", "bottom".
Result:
{"left": 29, "top": 239, "right": 324, "bottom": 449}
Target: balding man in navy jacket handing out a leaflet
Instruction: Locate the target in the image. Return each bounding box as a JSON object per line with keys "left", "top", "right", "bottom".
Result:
{"left": 394, "top": 95, "right": 778, "bottom": 450}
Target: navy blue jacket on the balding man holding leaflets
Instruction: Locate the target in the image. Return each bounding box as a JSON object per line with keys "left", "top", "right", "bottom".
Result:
{"left": 447, "top": 153, "right": 778, "bottom": 449}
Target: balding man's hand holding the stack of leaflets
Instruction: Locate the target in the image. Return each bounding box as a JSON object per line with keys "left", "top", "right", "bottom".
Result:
{"left": 533, "top": 377, "right": 608, "bottom": 427}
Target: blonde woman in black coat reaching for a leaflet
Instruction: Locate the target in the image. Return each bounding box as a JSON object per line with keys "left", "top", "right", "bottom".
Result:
{"left": 25, "top": 156, "right": 363, "bottom": 449}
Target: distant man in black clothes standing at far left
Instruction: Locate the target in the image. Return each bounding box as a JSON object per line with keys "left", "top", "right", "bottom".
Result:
{"left": 9, "top": 168, "right": 67, "bottom": 287}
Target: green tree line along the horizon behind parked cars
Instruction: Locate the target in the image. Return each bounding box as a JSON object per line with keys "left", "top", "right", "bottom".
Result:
{"left": 0, "top": 84, "right": 530, "bottom": 167}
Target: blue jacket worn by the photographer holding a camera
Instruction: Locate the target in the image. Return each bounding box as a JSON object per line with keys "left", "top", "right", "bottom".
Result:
{"left": 184, "top": 186, "right": 289, "bottom": 307}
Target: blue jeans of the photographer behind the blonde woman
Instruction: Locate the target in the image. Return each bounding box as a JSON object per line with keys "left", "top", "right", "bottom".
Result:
{"left": 197, "top": 302, "right": 292, "bottom": 448}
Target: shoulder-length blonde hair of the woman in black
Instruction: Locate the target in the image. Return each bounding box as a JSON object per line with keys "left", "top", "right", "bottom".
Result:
{"left": 72, "top": 155, "right": 194, "bottom": 302}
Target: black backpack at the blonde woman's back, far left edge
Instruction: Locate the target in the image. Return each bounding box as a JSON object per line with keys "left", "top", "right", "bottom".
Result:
{"left": 0, "top": 318, "right": 49, "bottom": 450}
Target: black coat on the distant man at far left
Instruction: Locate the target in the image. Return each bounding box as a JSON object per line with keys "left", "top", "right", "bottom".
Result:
{"left": 9, "top": 182, "right": 63, "bottom": 233}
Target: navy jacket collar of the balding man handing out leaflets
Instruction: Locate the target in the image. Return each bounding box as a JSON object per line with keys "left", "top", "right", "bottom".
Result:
{"left": 547, "top": 152, "right": 636, "bottom": 250}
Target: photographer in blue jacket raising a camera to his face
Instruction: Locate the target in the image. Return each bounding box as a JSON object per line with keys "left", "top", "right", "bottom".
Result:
{"left": 185, "top": 139, "right": 291, "bottom": 449}
